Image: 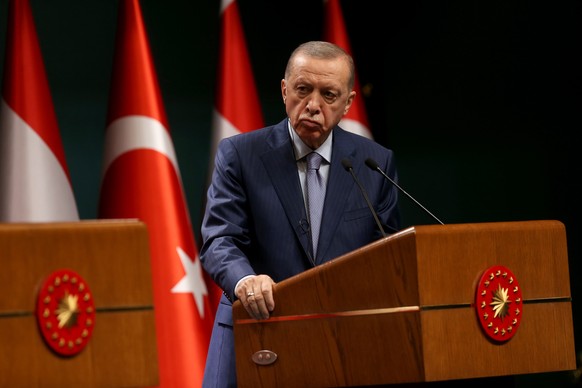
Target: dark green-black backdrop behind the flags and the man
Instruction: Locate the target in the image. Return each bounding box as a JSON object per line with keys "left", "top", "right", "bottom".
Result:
{"left": 0, "top": 0, "right": 582, "bottom": 386}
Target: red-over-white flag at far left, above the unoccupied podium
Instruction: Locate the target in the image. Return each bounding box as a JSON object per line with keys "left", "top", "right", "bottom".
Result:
{"left": 0, "top": 0, "right": 79, "bottom": 222}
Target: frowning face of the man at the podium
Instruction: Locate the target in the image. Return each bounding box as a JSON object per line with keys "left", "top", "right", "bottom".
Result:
{"left": 281, "top": 55, "right": 356, "bottom": 149}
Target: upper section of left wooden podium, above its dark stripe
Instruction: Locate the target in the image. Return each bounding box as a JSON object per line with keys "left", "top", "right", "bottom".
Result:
{"left": 0, "top": 219, "right": 153, "bottom": 314}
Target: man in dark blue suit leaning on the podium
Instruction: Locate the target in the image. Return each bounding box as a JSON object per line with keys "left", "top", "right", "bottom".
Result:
{"left": 200, "top": 41, "right": 400, "bottom": 388}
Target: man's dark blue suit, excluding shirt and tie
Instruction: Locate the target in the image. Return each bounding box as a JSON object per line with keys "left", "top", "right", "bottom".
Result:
{"left": 200, "top": 119, "right": 400, "bottom": 387}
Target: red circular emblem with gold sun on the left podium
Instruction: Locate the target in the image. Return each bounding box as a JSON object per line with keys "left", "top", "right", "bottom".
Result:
{"left": 36, "top": 269, "right": 95, "bottom": 356}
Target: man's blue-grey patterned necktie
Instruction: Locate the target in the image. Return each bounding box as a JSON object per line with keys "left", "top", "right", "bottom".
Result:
{"left": 305, "top": 152, "right": 325, "bottom": 260}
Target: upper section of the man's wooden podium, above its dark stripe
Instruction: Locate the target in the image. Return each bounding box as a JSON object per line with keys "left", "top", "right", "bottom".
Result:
{"left": 233, "top": 220, "right": 570, "bottom": 319}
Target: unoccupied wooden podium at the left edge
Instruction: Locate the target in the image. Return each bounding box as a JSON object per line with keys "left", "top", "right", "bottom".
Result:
{"left": 0, "top": 220, "right": 158, "bottom": 387}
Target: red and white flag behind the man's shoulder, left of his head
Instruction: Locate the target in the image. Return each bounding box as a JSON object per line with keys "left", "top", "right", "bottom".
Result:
{"left": 210, "top": 0, "right": 264, "bottom": 177}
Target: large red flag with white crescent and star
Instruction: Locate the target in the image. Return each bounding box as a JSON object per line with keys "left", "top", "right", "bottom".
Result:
{"left": 99, "top": 0, "right": 215, "bottom": 387}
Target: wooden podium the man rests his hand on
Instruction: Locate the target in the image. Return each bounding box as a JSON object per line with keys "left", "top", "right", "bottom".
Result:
{"left": 233, "top": 221, "right": 576, "bottom": 387}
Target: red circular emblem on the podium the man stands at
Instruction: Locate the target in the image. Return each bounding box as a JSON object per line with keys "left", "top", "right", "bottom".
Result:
{"left": 475, "top": 265, "right": 523, "bottom": 342}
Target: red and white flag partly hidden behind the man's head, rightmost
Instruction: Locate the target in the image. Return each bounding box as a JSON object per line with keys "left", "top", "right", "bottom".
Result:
{"left": 323, "top": 0, "right": 372, "bottom": 139}
